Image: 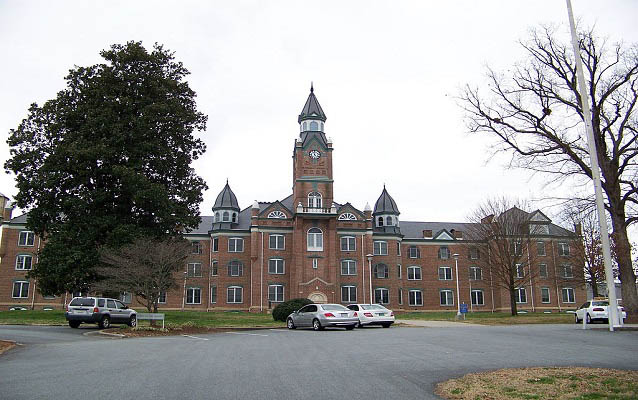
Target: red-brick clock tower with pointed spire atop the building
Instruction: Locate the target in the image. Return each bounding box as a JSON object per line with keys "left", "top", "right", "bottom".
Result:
{"left": 292, "top": 86, "right": 333, "bottom": 214}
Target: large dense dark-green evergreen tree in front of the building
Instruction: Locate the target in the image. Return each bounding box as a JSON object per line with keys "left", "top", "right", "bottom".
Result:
{"left": 5, "top": 42, "right": 207, "bottom": 294}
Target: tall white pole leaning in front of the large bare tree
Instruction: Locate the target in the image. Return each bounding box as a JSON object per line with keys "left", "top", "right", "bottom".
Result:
{"left": 566, "top": 0, "right": 620, "bottom": 332}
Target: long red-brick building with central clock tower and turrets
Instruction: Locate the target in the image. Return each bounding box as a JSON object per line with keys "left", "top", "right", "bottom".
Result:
{"left": 0, "top": 88, "right": 586, "bottom": 311}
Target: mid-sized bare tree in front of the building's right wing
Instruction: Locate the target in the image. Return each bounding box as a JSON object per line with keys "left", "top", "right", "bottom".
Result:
{"left": 468, "top": 198, "right": 539, "bottom": 315}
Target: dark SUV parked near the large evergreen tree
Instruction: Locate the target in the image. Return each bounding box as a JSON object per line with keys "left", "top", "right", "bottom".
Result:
{"left": 64, "top": 297, "right": 137, "bottom": 328}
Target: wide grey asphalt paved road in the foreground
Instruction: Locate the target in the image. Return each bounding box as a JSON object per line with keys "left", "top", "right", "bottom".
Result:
{"left": 0, "top": 325, "right": 638, "bottom": 400}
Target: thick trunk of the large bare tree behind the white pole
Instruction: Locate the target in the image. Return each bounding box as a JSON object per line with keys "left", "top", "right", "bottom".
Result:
{"left": 611, "top": 215, "right": 638, "bottom": 322}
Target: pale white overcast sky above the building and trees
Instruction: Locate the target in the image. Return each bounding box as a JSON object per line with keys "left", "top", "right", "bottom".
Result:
{"left": 0, "top": 0, "right": 638, "bottom": 228}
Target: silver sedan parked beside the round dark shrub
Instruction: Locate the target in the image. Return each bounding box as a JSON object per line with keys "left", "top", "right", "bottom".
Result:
{"left": 286, "top": 304, "right": 359, "bottom": 331}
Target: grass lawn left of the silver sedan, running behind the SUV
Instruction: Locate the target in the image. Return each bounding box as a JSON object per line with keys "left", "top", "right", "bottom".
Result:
{"left": 0, "top": 309, "right": 284, "bottom": 328}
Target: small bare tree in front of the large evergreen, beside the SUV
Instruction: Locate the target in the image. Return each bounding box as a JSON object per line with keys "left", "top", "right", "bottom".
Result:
{"left": 94, "top": 238, "right": 191, "bottom": 312}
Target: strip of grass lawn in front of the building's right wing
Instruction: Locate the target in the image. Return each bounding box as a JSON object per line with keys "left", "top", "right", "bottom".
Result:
{"left": 395, "top": 312, "right": 574, "bottom": 325}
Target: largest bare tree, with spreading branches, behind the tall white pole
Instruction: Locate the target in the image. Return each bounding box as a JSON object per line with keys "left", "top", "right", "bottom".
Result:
{"left": 460, "top": 27, "right": 638, "bottom": 315}
